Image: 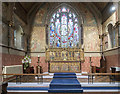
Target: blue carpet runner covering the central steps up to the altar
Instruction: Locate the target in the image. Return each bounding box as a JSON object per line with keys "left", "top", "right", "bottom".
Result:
{"left": 48, "top": 73, "right": 83, "bottom": 93}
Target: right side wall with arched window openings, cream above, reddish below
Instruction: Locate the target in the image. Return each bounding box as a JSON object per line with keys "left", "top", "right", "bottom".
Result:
{"left": 103, "top": 6, "right": 120, "bottom": 72}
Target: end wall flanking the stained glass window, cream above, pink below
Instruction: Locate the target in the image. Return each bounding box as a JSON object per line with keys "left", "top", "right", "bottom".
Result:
{"left": 30, "top": 3, "right": 101, "bottom": 72}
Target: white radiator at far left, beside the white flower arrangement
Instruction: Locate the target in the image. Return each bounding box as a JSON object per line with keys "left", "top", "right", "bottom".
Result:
{"left": 2, "top": 65, "right": 23, "bottom": 78}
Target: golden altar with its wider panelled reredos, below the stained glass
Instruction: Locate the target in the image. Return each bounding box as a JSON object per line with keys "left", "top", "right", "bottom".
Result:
{"left": 46, "top": 48, "right": 84, "bottom": 72}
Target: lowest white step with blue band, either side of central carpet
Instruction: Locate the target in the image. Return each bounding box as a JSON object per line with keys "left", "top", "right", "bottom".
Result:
{"left": 7, "top": 82, "right": 120, "bottom": 94}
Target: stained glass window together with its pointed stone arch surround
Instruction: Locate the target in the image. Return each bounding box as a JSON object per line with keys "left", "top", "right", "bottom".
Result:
{"left": 46, "top": 3, "right": 83, "bottom": 48}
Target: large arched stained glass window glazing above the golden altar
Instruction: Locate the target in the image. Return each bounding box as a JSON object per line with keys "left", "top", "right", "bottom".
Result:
{"left": 49, "top": 7, "right": 81, "bottom": 48}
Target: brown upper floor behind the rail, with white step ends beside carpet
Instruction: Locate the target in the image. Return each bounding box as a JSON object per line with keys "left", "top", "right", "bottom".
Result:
{"left": 4, "top": 74, "right": 118, "bottom": 82}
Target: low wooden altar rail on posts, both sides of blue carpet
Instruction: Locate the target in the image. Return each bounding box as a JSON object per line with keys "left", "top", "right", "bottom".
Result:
{"left": 0, "top": 73, "right": 120, "bottom": 84}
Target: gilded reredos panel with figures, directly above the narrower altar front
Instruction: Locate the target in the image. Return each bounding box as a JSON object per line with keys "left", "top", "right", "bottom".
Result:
{"left": 46, "top": 48, "right": 84, "bottom": 61}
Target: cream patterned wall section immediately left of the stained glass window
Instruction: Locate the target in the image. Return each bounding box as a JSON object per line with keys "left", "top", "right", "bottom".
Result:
{"left": 30, "top": 26, "right": 46, "bottom": 52}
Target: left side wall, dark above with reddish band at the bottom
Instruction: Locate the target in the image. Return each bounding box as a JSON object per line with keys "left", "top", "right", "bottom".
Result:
{"left": 0, "top": 3, "right": 27, "bottom": 70}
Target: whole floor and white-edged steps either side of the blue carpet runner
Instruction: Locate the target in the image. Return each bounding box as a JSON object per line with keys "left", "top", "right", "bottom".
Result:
{"left": 4, "top": 73, "right": 120, "bottom": 94}
